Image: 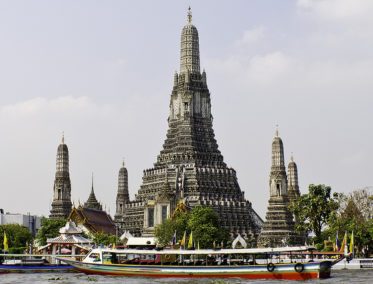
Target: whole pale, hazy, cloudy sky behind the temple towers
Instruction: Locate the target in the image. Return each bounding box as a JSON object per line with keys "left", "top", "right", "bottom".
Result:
{"left": 0, "top": 0, "right": 373, "bottom": 218}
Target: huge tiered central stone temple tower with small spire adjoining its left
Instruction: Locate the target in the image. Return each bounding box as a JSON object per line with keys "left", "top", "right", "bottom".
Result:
{"left": 115, "top": 9, "right": 263, "bottom": 239}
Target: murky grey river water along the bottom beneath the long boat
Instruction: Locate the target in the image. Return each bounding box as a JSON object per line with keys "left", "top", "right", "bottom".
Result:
{"left": 0, "top": 269, "right": 373, "bottom": 284}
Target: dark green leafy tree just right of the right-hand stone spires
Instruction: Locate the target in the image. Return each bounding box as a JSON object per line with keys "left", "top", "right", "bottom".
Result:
{"left": 290, "top": 184, "right": 339, "bottom": 242}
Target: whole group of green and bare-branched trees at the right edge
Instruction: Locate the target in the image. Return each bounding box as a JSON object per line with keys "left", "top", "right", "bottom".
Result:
{"left": 290, "top": 185, "right": 373, "bottom": 257}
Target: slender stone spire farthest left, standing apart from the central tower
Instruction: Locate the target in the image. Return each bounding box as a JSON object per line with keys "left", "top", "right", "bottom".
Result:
{"left": 49, "top": 135, "right": 72, "bottom": 219}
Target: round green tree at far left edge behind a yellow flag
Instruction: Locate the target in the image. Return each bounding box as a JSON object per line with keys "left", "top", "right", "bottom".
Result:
{"left": 0, "top": 224, "right": 32, "bottom": 253}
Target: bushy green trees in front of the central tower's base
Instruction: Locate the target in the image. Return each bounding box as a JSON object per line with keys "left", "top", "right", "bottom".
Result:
{"left": 155, "top": 206, "right": 229, "bottom": 248}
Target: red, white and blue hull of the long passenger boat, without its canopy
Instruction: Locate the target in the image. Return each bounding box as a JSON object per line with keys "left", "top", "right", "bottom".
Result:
{"left": 61, "top": 259, "right": 332, "bottom": 280}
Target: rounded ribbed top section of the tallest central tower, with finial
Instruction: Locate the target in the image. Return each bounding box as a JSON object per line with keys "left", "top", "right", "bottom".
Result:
{"left": 180, "top": 7, "right": 200, "bottom": 74}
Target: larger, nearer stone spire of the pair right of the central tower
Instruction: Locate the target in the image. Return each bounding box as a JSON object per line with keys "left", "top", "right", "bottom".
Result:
{"left": 258, "top": 130, "right": 303, "bottom": 247}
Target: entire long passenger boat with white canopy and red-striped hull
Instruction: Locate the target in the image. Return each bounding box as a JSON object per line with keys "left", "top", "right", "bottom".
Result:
{"left": 59, "top": 246, "right": 345, "bottom": 280}
